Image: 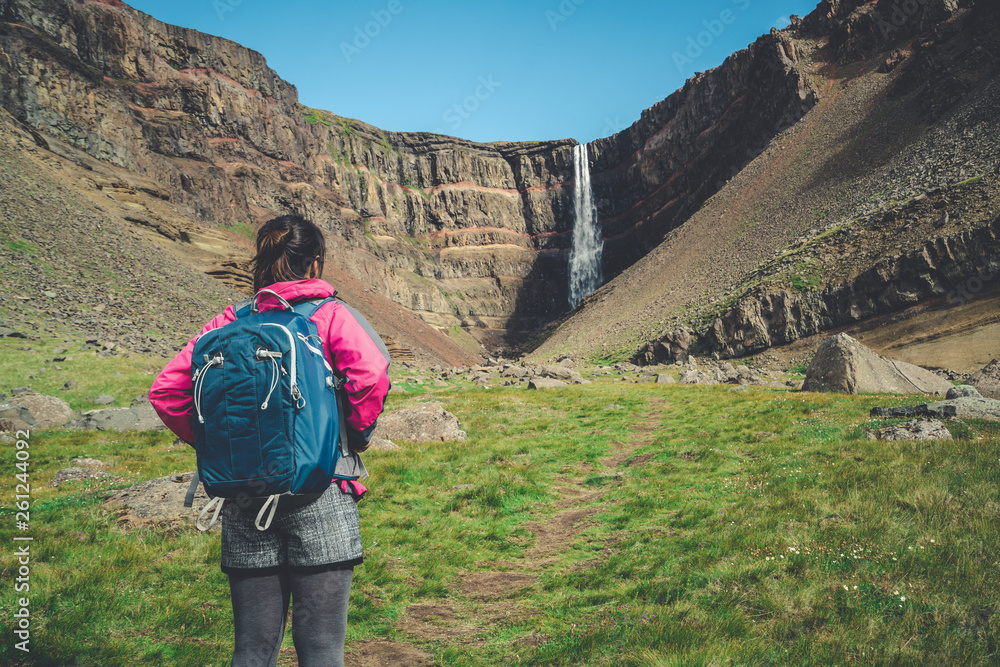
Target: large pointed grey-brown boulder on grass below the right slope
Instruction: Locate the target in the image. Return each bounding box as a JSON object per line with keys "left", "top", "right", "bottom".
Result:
{"left": 802, "top": 334, "right": 952, "bottom": 396}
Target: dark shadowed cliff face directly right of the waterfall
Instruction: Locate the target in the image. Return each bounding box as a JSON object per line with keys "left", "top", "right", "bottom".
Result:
{"left": 592, "top": 30, "right": 819, "bottom": 275}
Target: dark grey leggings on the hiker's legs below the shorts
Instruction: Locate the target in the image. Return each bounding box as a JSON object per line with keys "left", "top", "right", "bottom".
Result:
{"left": 229, "top": 570, "right": 354, "bottom": 667}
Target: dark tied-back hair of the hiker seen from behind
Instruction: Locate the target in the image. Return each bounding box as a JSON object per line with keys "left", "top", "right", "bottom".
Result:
{"left": 253, "top": 215, "right": 326, "bottom": 292}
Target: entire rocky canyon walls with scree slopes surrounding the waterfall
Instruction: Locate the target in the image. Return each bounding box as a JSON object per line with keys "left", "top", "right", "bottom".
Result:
{"left": 0, "top": 0, "right": 998, "bottom": 364}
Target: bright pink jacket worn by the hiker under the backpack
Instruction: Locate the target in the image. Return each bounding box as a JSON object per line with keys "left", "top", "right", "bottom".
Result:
{"left": 149, "top": 280, "right": 389, "bottom": 442}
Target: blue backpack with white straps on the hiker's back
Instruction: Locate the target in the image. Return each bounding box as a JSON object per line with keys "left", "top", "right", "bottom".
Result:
{"left": 185, "top": 289, "right": 368, "bottom": 530}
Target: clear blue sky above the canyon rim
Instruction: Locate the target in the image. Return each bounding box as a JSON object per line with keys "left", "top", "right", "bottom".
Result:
{"left": 126, "top": 0, "right": 816, "bottom": 142}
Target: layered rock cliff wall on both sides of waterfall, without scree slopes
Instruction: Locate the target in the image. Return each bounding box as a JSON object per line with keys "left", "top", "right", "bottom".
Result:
{"left": 0, "top": 0, "right": 817, "bottom": 344}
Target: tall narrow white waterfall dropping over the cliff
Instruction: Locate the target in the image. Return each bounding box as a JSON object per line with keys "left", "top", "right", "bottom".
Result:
{"left": 569, "top": 144, "right": 604, "bottom": 308}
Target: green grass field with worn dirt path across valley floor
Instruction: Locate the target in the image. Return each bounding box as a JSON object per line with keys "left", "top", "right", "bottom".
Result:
{"left": 0, "top": 348, "right": 1000, "bottom": 667}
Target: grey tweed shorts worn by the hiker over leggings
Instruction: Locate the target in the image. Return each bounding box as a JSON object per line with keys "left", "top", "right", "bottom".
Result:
{"left": 222, "top": 484, "right": 362, "bottom": 574}
